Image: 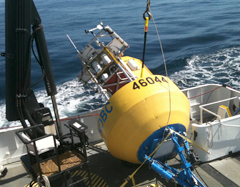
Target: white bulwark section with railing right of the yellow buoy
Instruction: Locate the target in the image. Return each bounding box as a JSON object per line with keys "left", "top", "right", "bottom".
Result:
{"left": 183, "top": 84, "right": 240, "bottom": 162}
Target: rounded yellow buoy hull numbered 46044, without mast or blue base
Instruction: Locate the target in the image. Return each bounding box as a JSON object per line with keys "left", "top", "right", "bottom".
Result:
{"left": 98, "top": 75, "right": 190, "bottom": 163}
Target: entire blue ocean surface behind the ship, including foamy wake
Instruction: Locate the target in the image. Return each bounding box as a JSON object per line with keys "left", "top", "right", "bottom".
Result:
{"left": 0, "top": 0, "right": 240, "bottom": 127}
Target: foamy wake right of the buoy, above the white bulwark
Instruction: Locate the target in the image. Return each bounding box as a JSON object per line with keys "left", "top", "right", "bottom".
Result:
{"left": 170, "top": 47, "right": 240, "bottom": 89}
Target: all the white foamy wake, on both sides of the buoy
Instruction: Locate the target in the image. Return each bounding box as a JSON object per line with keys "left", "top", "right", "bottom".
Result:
{"left": 0, "top": 47, "right": 240, "bottom": 128}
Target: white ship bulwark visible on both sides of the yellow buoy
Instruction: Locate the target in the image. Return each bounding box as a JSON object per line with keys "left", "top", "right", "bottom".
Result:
{"left": 0, "top": 84, "right": 240, "bottom": 165}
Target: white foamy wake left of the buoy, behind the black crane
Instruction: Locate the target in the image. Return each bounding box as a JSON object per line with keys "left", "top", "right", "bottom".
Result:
{"left": 0, "top": 78, "right": 105, "bottom": 128}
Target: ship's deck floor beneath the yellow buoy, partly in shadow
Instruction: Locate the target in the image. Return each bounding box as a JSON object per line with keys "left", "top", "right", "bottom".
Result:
{"left": 0, "top": 142, "right": 240, "bottom": 187}
